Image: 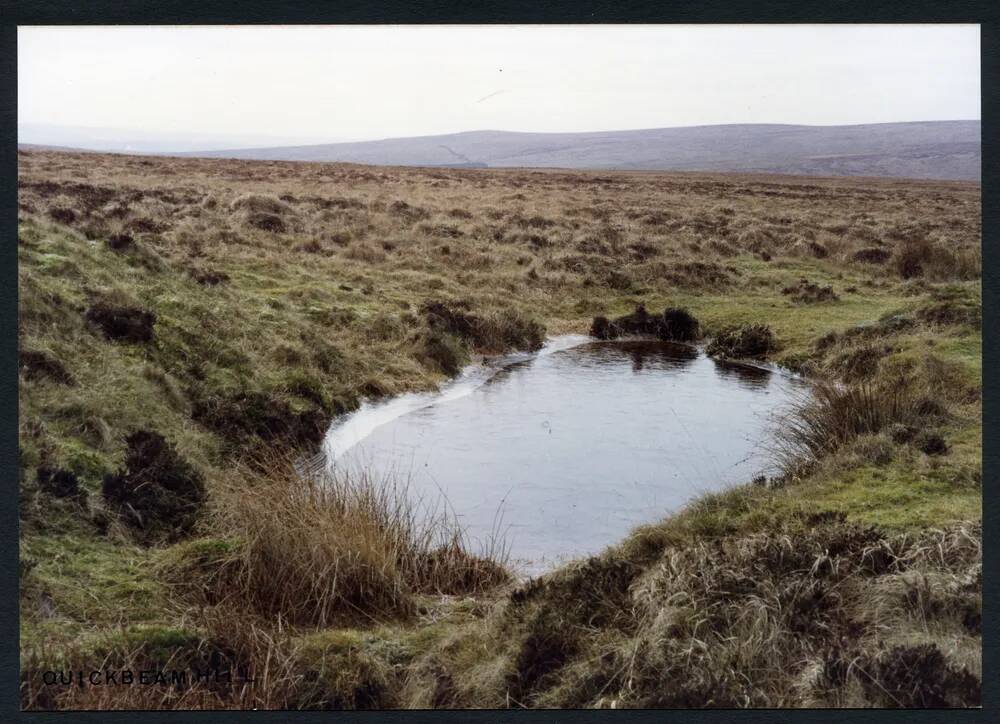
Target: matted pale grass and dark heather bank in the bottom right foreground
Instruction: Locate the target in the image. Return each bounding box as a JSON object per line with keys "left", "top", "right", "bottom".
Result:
{"left": 402, "top": 516, "right": 981, "bottom": 708}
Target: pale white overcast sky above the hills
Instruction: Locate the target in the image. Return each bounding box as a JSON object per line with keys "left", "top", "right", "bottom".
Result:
{"left": 18, "top": 25, "right": 980, "bottom": 150}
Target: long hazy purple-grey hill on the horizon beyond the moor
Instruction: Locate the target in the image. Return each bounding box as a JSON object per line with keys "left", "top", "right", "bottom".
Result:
{"left": 182, "top": 121, "right": 982, "bottom": 180}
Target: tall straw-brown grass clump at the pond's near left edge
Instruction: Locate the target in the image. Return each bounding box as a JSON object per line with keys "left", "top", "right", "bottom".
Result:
{"left": 164, "top": 459, "right": 510, "bottom": 626}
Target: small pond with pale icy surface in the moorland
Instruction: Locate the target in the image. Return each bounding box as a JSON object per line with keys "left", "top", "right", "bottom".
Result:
{"left": 324, "top": 336, "right": 803, "bottom": 573}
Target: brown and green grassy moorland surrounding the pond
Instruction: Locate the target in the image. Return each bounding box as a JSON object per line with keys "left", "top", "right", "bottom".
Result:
{"left": 18, "top": 151, "right": 982, "bottom": 708}
